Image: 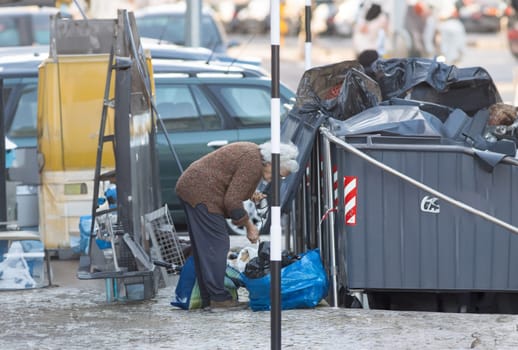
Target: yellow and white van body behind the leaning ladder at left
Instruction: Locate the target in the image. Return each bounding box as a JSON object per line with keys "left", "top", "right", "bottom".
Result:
{"left": 37, "top": 54, "right": 115, "bottom": 249}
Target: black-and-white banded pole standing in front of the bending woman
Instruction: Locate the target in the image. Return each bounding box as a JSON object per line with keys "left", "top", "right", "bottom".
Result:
{"left": 270, "top": 0, "right": 282, "bottom": 350}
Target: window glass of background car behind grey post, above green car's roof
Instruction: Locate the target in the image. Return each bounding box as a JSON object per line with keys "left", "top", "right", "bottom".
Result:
{"left": 136, "top": 15, "right": 222, "bottom": 49}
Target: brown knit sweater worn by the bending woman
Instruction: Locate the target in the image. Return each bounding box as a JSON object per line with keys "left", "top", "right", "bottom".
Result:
{"left": 176, "top": 142, "right": 263, "bottom": 226}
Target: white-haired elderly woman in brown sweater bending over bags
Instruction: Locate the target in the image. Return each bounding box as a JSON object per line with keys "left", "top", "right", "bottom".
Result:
{"left": 176, "top": 142, "right": 299, "bottom": 311}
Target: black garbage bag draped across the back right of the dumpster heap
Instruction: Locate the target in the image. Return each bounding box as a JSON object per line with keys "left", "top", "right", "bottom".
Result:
{"left": 372, "top": 58, "right": 502, "bottom": 115}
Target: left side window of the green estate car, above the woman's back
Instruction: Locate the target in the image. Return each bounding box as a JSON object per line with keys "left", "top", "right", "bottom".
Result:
{"left": 152, "top": 84, "right": 222, "bottom": 132}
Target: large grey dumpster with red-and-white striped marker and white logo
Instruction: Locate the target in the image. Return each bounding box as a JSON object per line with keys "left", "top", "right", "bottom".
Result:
{"left": 334, "top": 135, "right": 518, "bottom": 291}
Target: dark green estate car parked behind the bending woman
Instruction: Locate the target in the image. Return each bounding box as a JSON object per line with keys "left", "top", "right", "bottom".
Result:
{"left": 0, "top": 48, "right": 295, "bottom": 234}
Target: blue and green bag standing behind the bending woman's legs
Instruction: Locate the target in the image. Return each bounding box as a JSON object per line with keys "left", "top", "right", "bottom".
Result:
{"left": 171, "top": 255, "right": 243, "bottom": 310}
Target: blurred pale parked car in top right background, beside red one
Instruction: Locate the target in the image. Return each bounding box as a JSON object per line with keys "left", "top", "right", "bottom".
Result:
{"left": 459, "top": 0, "right": 508, "bottom": 32}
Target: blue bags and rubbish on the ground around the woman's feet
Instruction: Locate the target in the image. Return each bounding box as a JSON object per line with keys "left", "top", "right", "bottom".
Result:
{"left": 171, "top": 241, "right": 329, "bottom": 311}
